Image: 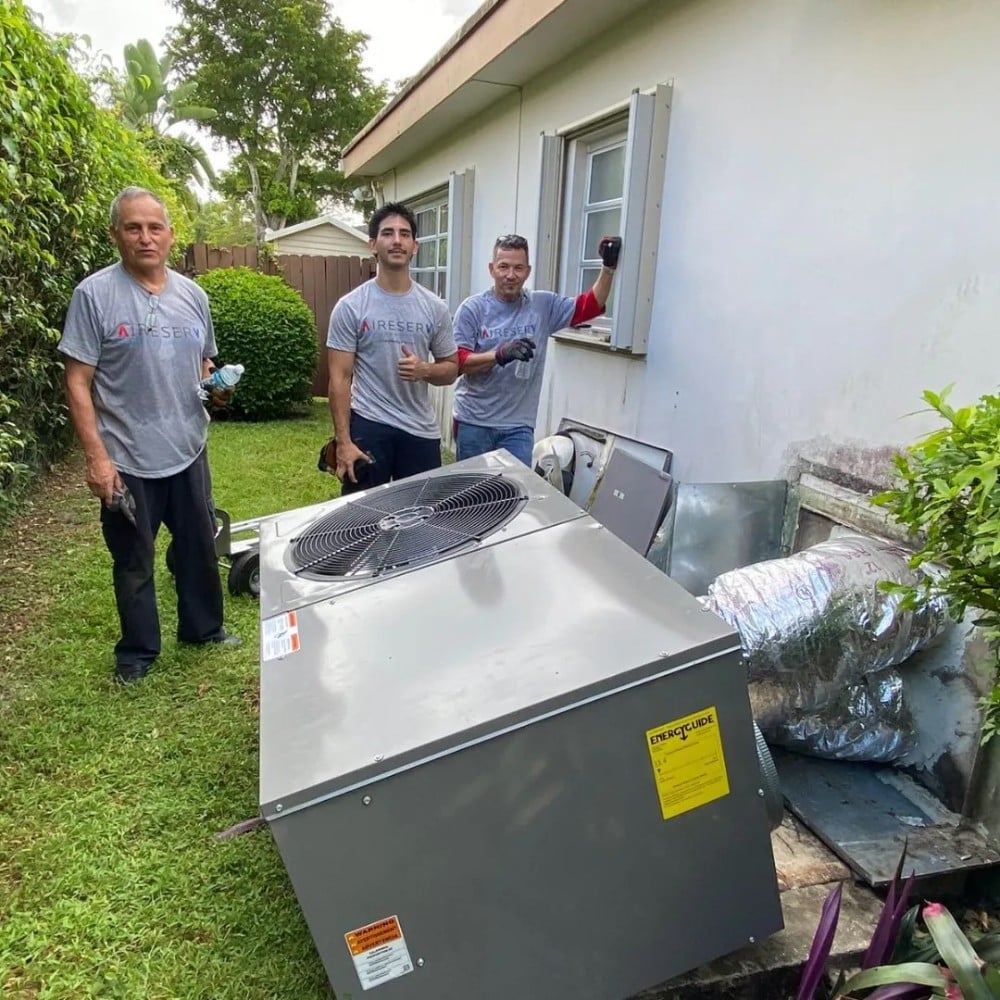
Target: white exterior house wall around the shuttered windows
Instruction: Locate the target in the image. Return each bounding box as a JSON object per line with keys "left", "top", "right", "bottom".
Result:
{"left": 384, "top": 0, "right": 1000, "bottom": 482}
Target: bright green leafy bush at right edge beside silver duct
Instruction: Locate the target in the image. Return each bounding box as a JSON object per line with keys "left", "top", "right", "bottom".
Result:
{"left": 874, "top": 386, "right": 1000, "bottom": 743}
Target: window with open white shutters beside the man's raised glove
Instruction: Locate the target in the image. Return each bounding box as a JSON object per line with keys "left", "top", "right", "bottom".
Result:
{"left": 534, "top": 84, "right": 671, "bottom": 355}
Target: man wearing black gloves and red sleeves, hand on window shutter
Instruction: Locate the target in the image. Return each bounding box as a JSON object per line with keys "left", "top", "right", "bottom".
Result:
{"left": 455, "top": 236, "right": 621, "bottom": 465}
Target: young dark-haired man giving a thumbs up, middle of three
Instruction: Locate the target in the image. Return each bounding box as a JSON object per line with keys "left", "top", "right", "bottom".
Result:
{"left": 326, "top": 203, "right": 458, "bottom": 493}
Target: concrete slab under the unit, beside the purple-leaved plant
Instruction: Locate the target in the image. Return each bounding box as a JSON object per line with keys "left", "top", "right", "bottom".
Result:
{"left": 631, "top": 813, "right": 882, "bottom": 1000}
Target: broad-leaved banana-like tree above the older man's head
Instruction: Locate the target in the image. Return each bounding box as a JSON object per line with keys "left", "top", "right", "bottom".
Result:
{"left": 107, "top": 38, "right": 216, "bottom": 204}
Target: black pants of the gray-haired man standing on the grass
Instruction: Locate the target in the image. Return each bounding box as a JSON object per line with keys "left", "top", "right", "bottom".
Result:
{"left": 101, "top": 451, "right": 223, "bottom": 664}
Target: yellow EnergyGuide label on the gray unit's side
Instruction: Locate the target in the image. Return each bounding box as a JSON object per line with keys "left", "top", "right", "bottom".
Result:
{"left": 646, "top": 706, "right": 729, "bottom": 819}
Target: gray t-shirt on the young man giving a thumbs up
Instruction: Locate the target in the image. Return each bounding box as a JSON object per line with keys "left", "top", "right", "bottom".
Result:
{"left": 326, "top": 278, "right": 456, "bottom": 438}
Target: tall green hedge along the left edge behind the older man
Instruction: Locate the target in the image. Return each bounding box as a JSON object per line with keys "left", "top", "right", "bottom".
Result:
{"left": 0, "top": 0, "right": 183, "bottom": 519}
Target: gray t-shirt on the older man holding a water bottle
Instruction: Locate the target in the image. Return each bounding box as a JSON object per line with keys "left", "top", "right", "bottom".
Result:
{"left": 59, "top": 263, "right": 216, "bottom": 479}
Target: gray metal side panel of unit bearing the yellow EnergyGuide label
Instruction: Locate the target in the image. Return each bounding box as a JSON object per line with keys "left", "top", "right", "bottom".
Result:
{"left": 271, "top": 651, "right": 782, "bottom": 1000}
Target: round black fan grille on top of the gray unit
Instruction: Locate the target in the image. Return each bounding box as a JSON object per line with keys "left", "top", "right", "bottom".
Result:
{"left": 290, "top": 473, "right": 526, "bottom": 579}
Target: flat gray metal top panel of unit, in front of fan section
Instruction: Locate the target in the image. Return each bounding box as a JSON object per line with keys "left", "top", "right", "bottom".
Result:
{"left": 260, "top": 517, "right": 752, "bottom": 816}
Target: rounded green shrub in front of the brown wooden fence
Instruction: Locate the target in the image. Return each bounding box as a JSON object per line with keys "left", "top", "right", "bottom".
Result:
{"left": 196, "top": 267, "right": 317, "bottom": 420}
